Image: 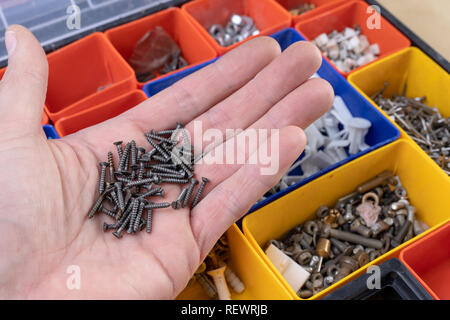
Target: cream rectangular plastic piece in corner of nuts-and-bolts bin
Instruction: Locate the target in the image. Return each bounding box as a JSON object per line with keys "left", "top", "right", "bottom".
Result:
{"left": 266, "top": 244, "right": 310, "bottom": 292}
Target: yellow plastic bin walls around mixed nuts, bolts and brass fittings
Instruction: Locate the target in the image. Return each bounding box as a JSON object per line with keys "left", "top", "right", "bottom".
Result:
{"left": 242, "top": 139, "right": 450, "bottom": 300}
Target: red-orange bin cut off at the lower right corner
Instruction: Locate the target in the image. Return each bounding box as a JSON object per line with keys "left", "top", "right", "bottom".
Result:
{"left": 400, "top": 220, "right": 450, "bottom": 300}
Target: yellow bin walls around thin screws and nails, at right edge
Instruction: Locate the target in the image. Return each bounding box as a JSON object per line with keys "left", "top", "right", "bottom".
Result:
{"left": 348, "top": 47, "right": 450, "bottom": 175}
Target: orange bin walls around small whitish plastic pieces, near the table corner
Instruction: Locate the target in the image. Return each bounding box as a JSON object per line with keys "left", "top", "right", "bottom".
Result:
{"left": 295, "top": 1, "right": 411, "bottom": 77}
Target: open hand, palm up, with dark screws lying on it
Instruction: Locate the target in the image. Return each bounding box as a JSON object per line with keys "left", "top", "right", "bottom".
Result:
{"left": 0, "top": 26, "right": 333, "bottom": 299}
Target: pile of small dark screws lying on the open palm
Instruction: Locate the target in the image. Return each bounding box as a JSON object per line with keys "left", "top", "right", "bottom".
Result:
{"left": 88, "top": 123, "right": 208, "bottom": 238}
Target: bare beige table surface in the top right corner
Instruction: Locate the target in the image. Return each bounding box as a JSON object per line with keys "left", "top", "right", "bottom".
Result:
{"left": 378, "top": 0, "right": 450, "bottom": 61}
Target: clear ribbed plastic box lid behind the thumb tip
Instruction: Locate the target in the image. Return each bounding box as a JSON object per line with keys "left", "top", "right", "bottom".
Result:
{"left": 0, "top": 0, "right": 185, "bottom": 66}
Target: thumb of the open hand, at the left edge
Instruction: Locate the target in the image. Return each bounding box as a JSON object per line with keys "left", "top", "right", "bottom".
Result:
{"left": 0, "top": 25, "right": 48, "bottom": 134}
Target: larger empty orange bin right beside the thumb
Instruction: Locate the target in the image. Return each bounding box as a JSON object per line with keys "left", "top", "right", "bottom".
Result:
{"left": 46, "top": 32, "right": 136, "bottom": 122}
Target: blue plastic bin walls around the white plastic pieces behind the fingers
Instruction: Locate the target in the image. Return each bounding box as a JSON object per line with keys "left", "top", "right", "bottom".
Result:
{"left": 248, "top": 28, "right": 400, "bottom": 213}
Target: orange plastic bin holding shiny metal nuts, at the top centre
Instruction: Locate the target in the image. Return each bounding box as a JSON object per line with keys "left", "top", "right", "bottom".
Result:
{"left": 182, "top": 0, "right": 291, "bottom": 55}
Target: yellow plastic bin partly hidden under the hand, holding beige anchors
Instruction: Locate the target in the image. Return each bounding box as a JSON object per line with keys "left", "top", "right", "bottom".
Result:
{"left": 177, "top": 224, "right": 292, "bottom": 300}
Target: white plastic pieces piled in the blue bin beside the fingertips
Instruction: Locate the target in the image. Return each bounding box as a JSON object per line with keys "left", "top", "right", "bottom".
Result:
{"left": 259, "top": 89, "right": 372, "bottom": 201}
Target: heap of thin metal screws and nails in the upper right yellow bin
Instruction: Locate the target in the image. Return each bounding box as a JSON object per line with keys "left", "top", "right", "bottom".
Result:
{"left": 372, "top": 83, "right": 450, "bottom": 175}
